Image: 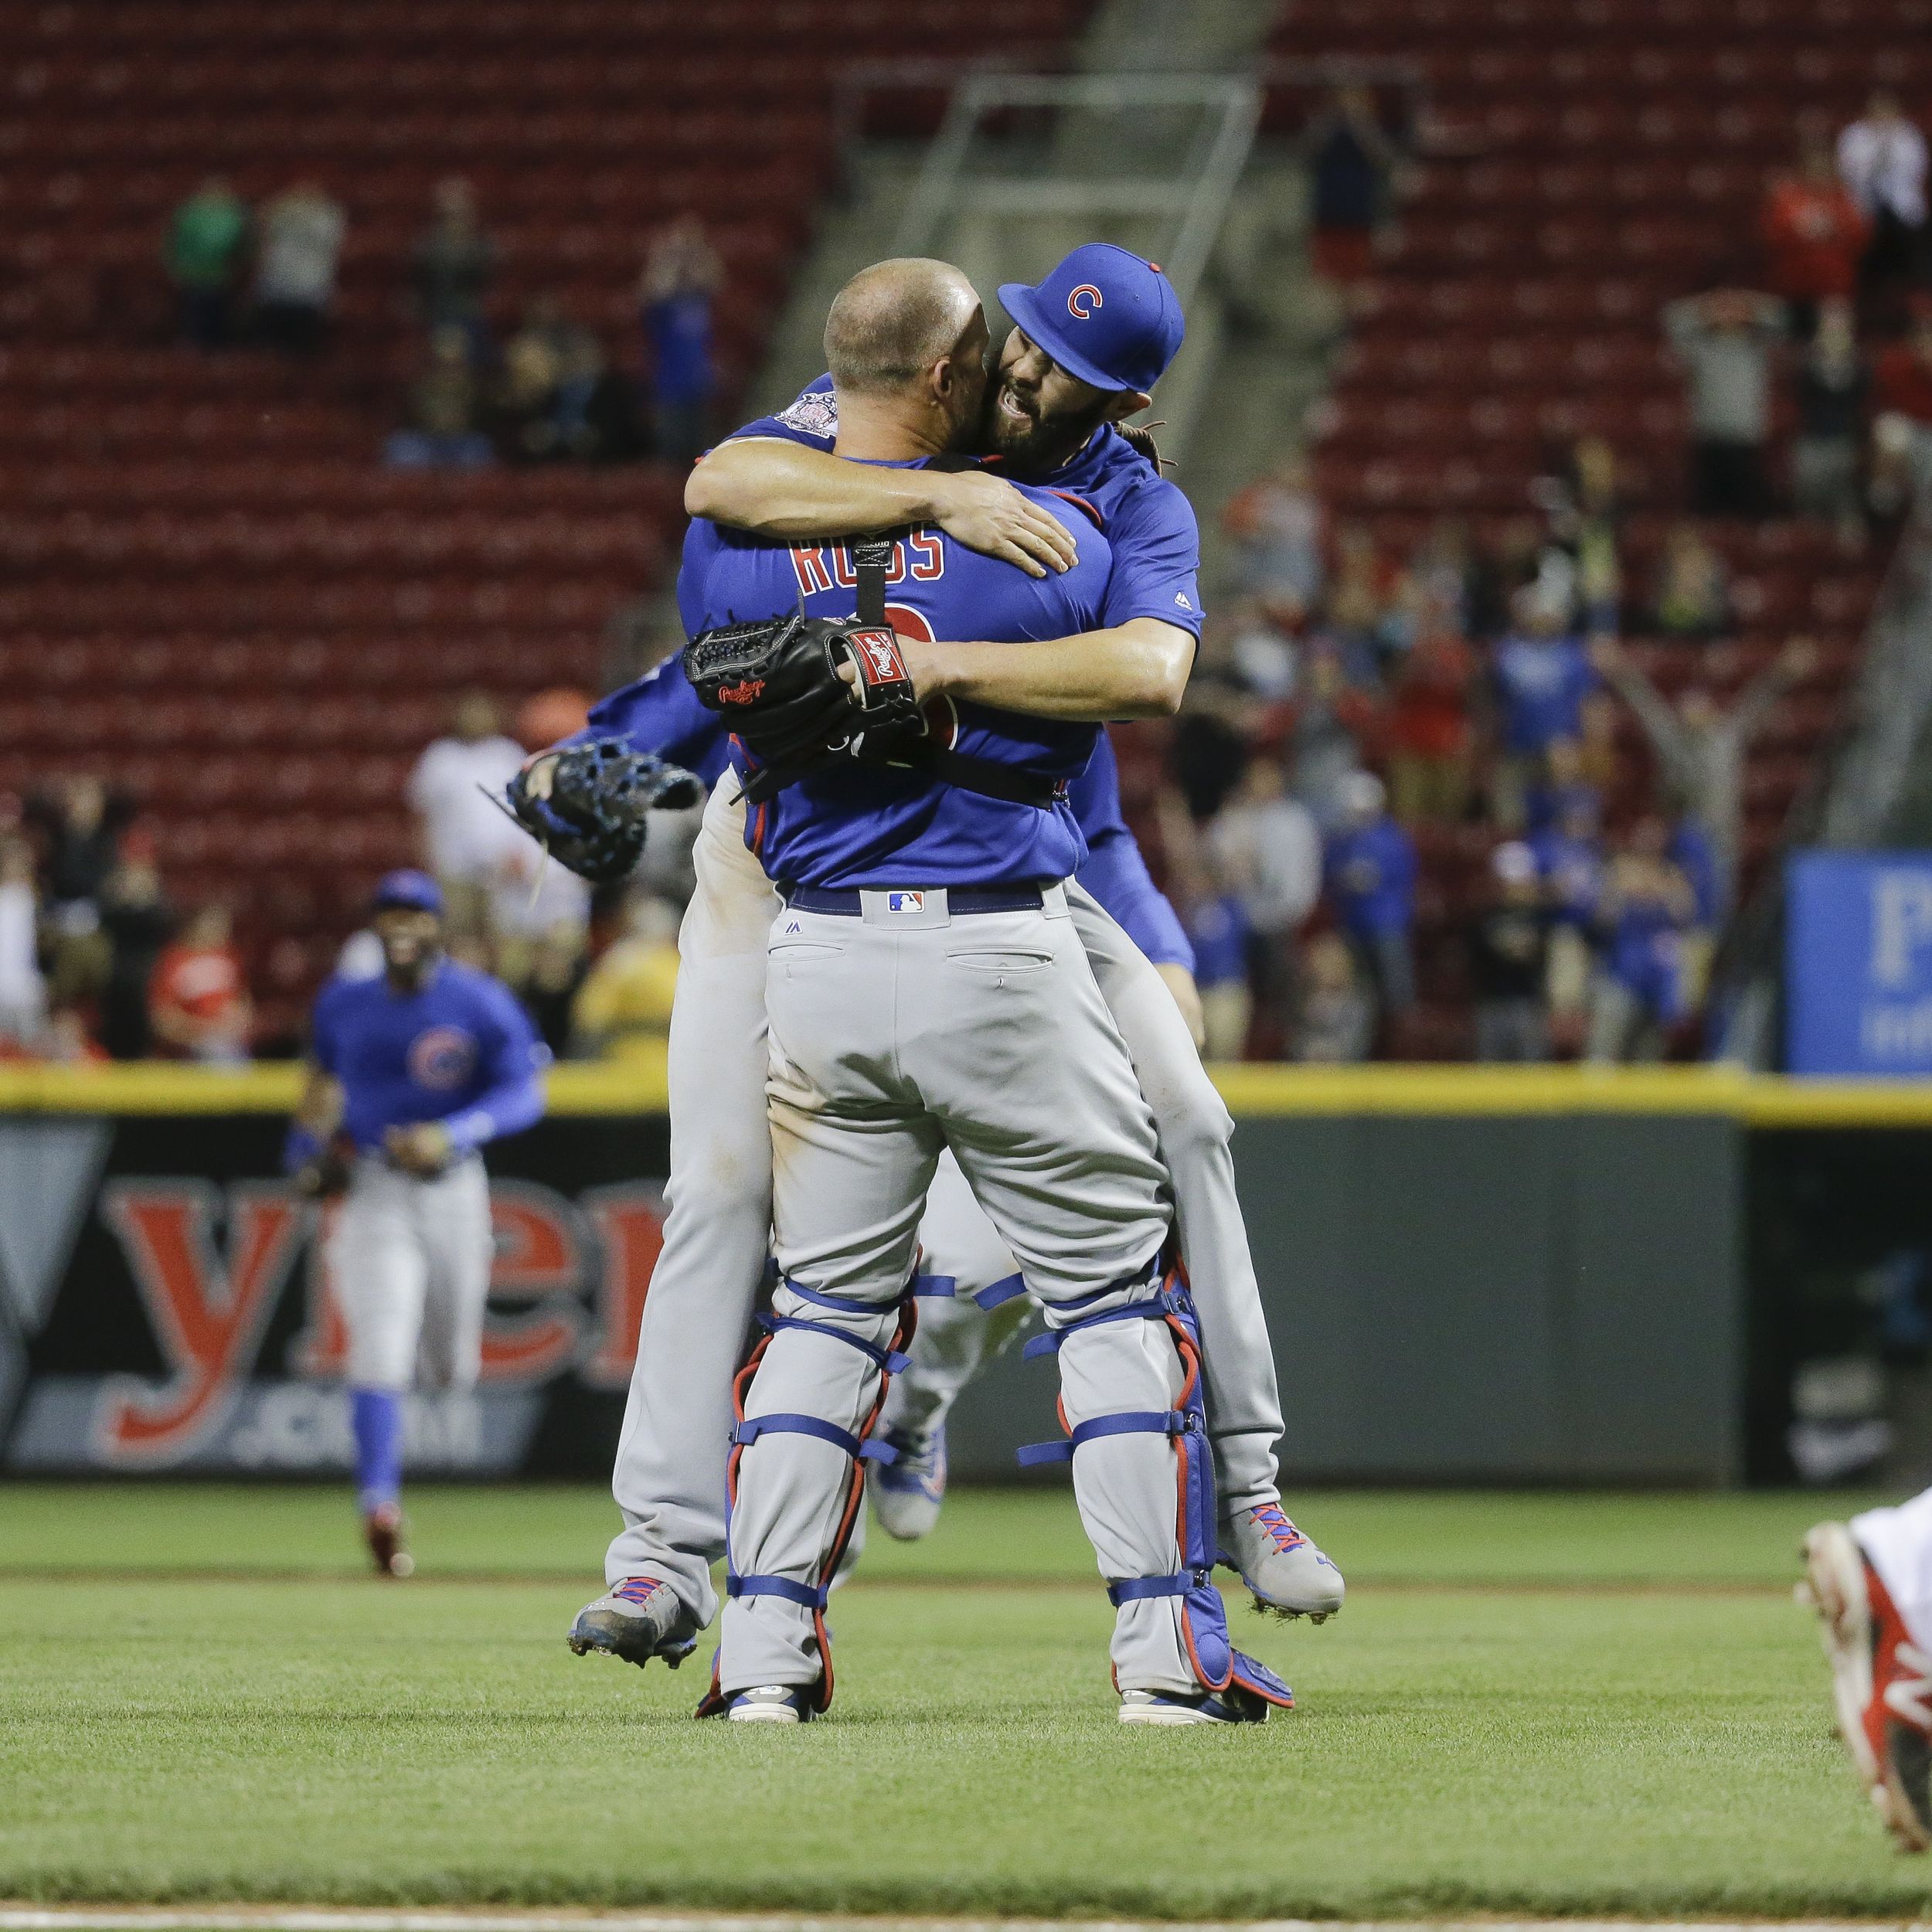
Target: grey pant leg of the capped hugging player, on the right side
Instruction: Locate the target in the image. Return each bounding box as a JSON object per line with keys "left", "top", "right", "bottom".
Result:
{"left": 1066, "top": 887, "right": 1281, "bottom": 1517}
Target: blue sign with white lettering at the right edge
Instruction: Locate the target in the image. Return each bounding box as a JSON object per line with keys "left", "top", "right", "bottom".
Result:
{"left": 1785, "top": 852, "right": 1932, "bottom": 1080}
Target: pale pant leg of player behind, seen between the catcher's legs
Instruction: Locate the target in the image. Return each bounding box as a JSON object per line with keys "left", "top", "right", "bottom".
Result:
{"left": 881, "top": 1150, "right": 1032, "bottom": 1436}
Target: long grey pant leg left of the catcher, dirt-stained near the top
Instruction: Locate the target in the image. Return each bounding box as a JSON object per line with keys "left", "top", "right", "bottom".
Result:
{"left": 605, "top": 773, "right": 779, "bottom": 1629}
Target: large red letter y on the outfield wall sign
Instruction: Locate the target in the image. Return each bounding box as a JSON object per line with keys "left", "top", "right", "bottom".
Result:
{"left": 95, "top": 1181, "right": 305, "bottom": 1464}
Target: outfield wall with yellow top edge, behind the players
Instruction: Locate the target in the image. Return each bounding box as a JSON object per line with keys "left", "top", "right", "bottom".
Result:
{"left": 0, "top": 1066, "right": 1932, "bottom": 1484}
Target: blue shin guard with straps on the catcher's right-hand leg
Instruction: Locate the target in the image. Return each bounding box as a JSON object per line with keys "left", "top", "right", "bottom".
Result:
{"left": 1020, "top": 1271, "right": 1294, "bottom": 1710}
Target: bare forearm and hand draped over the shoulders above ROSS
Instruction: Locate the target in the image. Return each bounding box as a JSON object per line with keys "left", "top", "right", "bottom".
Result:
{"left": 684, "top": 437, "right": 1080, "bottom": 578}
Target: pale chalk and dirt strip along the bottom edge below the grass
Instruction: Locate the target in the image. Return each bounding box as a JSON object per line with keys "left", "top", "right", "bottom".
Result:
{"left": 0, "top": 1905, "right": 1932, "bottom": 1932}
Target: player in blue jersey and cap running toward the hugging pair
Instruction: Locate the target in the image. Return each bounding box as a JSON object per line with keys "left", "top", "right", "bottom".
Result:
{"left": 282, "top": 872, "right": 549, "bottom": 1577}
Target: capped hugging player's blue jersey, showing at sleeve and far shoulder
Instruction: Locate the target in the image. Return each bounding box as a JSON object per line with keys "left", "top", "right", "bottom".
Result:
{"left": 736, "top": 375, "right": 1202, "bottom": 638}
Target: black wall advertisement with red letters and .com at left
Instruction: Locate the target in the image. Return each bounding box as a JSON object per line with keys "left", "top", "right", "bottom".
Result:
{"left": 0, "top": 1113, "right": 668, "bottom": 1476}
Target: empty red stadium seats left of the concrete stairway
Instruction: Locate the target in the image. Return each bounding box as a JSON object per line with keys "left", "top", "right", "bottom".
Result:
{"left": 0, "top": 0, "right": 1090, "bottom": 1036}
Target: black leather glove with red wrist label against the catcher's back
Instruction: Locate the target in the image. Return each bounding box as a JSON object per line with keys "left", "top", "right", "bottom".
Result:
{"left": 684, "top": 617, "right": 923, "bottom": 765}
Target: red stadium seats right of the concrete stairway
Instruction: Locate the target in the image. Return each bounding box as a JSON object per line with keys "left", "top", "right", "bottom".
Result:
{"left": 1270, "top": 0, "right": 1909, "bottom": 1057}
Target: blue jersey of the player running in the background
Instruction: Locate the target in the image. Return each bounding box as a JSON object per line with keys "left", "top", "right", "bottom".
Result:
{"left": 311, "top": 961, "right": 551, "bottom": 1151}
